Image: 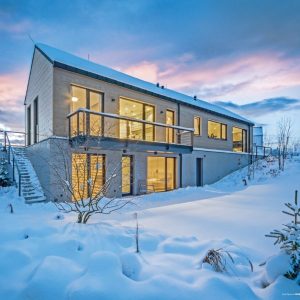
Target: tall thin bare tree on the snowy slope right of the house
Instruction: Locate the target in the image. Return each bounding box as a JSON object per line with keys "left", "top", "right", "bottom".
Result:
{"left": 277, "top": 117, "right": 292, "bottom": 171}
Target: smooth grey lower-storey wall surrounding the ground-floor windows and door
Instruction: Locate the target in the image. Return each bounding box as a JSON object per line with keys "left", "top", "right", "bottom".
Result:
{"left": 27, "top": 138, "right": 249, "bottom": 201}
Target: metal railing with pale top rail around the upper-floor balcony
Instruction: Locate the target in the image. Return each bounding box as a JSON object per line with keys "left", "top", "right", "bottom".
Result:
{"left": 67, "top": 108, "right": 194, "bottom": 147}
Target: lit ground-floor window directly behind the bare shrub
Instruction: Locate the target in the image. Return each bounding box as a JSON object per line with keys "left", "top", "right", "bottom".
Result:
{"left": 72, "top": 153, "right": 105, "bottom": 201}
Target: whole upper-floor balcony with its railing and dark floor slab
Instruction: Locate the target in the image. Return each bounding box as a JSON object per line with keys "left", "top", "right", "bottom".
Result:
{"left": 67, "top": 108, "right": 194, "bottom": 152}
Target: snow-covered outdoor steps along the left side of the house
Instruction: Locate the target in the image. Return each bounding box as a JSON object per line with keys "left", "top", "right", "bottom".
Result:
{"left": 12, "top": 147, "right": 46, "bottom": 203}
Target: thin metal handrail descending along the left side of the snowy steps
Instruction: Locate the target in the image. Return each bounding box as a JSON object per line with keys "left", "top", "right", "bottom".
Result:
{"left": 1, "top": 130, "right": 25, "bottom": 196}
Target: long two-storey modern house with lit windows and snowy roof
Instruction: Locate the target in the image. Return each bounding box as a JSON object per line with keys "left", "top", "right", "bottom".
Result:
{"left": 24, "top": 44, "right": 254, "bottom": 200}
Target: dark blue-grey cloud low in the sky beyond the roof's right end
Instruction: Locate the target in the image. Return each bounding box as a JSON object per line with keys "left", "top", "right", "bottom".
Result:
{"left": 214, "top": 97, "right": 300, "bottom": 117}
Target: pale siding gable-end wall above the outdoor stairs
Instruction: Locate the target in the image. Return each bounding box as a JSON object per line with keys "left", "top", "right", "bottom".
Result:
{"left": 25, "top": 50, "right": 53, "bottom": 142}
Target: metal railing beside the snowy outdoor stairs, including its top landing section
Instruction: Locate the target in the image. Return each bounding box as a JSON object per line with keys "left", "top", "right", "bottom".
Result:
{"left": 0, "top": 130, "right": 25, "bottom": 196}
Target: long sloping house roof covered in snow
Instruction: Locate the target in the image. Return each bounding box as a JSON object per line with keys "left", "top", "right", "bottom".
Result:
{"left": 35, "top": 43, "right": 253, "bottom": 125}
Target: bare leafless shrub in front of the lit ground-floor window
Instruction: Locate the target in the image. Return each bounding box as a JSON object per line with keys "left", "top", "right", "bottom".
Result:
{"left": 42, "top": 118, "right": 136, "bottom": 224}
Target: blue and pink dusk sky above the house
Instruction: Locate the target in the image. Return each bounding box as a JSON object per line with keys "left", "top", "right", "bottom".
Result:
{"left": 0, "top": 0, "right": 300, "bottom": 138}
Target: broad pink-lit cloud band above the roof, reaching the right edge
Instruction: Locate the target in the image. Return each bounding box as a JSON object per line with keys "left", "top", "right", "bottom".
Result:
{"left": 122, "top": 53, "right": 300, "bottom": 102}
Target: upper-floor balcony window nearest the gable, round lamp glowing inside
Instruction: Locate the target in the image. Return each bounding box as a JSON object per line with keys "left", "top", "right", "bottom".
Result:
{"left": 71, "top": 86, "right": 103, "bottom": 136}
